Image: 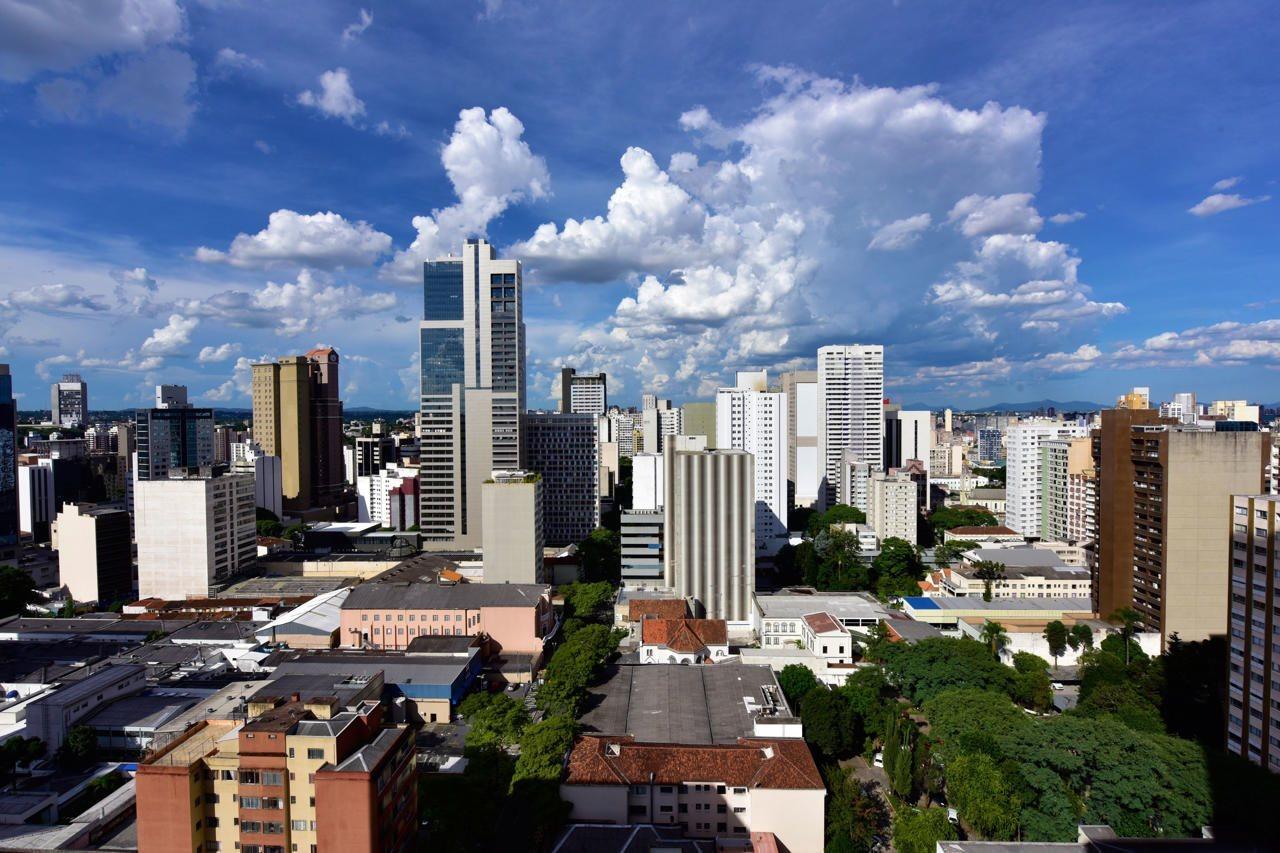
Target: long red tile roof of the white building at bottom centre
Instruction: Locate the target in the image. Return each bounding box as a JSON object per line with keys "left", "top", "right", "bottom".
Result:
{"left": 564, "top": 736, "right": 823, "bottom": 789}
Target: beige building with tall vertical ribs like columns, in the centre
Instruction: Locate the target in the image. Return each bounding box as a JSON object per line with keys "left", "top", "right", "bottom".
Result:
{"left": 663, "top": 448, "right": 755, "bottom": 622}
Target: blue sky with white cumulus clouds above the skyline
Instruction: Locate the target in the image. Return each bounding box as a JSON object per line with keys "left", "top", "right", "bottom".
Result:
{"left": 0, "top": 0, "right": 1280, "bottom": 410}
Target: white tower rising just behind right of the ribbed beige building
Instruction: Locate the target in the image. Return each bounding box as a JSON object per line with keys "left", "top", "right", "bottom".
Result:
{"left": 716, "top": 370, "right": 787, "bottom": 540}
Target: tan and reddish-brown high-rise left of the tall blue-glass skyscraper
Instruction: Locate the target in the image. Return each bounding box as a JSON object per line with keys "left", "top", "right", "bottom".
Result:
{"left": 252, "top": 347, "right": 347, "bottom": 514}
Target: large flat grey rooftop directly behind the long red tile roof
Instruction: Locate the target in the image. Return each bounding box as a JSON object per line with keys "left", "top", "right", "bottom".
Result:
{"left": 580, "top": 663, "right": 791, "bottom": 744}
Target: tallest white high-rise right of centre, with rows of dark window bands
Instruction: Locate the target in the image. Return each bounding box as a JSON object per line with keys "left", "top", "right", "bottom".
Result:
{"left": 818, "top": 343, "right": 884, "bottom": 510}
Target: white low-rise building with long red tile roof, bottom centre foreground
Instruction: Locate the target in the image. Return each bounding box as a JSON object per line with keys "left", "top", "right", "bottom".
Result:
{"left": 561, "top": 732, "right": 827, "bottom": 850}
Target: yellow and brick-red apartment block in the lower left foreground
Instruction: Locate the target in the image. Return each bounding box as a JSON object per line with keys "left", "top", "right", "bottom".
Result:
{"left": 136, "top": 691, "right": 419, "bottom": 853}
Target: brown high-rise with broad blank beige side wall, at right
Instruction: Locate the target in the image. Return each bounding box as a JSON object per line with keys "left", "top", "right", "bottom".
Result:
{"left": 1092, "top": 409, "right": 1268, "bottom": 643}
